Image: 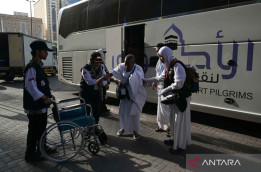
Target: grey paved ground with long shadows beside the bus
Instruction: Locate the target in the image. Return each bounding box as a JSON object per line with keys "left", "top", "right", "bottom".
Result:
{"left": 0, "top": 77, "right": 261, "bottom": 172}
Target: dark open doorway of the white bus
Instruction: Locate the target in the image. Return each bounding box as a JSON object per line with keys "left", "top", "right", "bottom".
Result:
{"left": 124, "top": 24, "right": 145, "bottom": 68}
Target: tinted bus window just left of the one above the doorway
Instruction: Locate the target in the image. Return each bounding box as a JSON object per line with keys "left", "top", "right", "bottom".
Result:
{"left": 88, "top": 0, "right": 119, "bottom": 29}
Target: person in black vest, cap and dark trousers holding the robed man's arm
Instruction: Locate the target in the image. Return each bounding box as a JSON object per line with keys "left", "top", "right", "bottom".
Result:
{"left": 80, "top": 52, "right": 105, "bottom": 124}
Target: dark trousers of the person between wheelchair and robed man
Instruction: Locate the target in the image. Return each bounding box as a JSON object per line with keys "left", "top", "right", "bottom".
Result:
{"left": 80, "top": 89, "right": 101, "bottom": 124}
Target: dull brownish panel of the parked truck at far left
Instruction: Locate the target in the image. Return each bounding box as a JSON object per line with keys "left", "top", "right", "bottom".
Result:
{"left": 8, "top": 34, "right": 25, "bottom": 67}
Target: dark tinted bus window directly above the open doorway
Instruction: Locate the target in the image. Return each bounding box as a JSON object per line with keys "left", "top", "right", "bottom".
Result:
{"left": 119, "top": 0, "right": 161, "bottom": 23}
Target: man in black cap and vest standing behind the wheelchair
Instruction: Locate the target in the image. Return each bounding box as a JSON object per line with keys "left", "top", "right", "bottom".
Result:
{"left": 23, "top": 40, "right": 52, "bottom": 162}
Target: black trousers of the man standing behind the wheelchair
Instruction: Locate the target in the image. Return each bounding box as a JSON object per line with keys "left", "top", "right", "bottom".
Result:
{"left": 26, "top": 113, "right": 47, "bottom": 154}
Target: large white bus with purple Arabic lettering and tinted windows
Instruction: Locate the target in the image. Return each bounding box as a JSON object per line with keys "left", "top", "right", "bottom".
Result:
{"left": 58, "top": 0, "right": 261, "bottom": 123}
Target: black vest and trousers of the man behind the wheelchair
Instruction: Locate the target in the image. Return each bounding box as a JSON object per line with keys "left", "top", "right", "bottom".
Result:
{"left": 23, "top": 60, "right": 51, "bottom": 157}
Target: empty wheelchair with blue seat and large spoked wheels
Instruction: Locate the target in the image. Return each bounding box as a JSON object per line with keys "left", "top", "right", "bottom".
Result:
{"left": 39, "top": 97, "right": 107, "bottom": 162}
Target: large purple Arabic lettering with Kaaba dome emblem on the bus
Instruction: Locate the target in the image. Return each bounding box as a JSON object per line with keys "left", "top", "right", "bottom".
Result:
{"left": 163, "top": 24, "right": 255, "bottom": 80}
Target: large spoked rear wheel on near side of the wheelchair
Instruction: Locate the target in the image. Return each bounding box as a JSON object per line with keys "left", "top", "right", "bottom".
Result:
{"left": 40, "top": 121, "right": 84, "bottom": 162}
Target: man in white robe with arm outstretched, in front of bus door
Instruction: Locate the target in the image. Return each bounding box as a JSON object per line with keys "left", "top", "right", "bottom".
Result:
{"left": 97, "top": 54, "right": 146, "bottom": 140}
